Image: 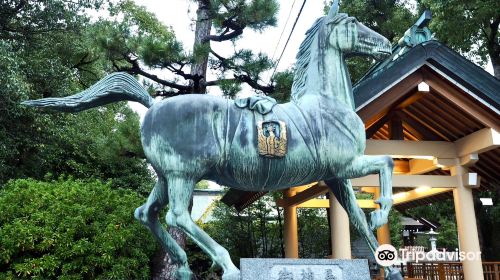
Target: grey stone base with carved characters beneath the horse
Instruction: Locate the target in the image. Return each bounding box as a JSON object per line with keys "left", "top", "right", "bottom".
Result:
{"left": 240, "top": 259, "right": 370, "bottom": 280}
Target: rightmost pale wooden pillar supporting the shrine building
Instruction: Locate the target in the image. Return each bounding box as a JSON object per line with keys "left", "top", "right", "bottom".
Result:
{"left": 450, "top": 165, "right": 484, "bottom": 280}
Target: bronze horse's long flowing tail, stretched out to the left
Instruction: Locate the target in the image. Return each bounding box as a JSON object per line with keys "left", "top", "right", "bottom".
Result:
{"left": 22, "top": 72, "right": 154, "bottom": 112}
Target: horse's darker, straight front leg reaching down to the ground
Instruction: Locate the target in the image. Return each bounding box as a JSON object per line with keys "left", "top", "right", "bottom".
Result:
{"left": 326, "top": 180, "right": 403, "bottom": 280}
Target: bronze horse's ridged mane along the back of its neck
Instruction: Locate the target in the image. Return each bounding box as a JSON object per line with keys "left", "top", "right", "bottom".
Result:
{"left": 291, "top": 17, "right": 325, "bottom": 100}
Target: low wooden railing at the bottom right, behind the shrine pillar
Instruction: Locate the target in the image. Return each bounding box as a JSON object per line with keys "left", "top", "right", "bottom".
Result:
{"left": 400, "top": 262, "right": 500, "bottom": 280}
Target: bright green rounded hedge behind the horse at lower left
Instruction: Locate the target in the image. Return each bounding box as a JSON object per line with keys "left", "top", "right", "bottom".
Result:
{"left": 0, "top": 179, "right": 157, "bottom": 279}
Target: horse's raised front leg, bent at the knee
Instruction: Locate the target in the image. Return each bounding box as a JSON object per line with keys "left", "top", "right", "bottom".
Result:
{"left": 338, "top": 156, "right": 394, "bottom": 229}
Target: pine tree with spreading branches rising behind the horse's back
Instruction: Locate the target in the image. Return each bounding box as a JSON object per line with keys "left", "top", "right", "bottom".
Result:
{"left": 100, "top": 0, "right": 290, "bottom": 97}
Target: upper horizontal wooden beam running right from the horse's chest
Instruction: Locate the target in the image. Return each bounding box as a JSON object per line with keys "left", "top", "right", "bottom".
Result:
{"left": 365, "top": 139, "right": 457, "bottom": 159}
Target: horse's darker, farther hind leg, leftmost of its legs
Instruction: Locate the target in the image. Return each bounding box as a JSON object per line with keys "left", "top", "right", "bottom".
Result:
{"left": 134, "top": 176, "right": 192, "bottom": 280}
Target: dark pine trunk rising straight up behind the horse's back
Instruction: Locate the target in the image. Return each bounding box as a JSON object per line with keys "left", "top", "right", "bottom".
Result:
{"left": 190, "top": 0, "right": 212, "bottom": 93}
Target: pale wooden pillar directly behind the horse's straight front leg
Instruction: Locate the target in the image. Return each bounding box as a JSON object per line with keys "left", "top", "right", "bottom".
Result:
{"left": 328, "top": 192, "right": 351, "bottom": 259}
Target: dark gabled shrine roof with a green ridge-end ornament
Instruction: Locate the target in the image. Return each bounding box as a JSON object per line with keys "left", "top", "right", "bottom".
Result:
{"left": 353, "top": 11, "right": 500, "bottom": 110}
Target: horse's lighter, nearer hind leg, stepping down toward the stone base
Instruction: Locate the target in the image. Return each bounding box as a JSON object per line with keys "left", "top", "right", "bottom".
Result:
{"left": 166, "top": 175, "right": 240, "bottom": 280}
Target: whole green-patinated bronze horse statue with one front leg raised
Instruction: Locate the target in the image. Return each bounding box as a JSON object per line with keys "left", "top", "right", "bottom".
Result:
{"left": 24, "top": 1, "right": 402, "bottom": 280}
